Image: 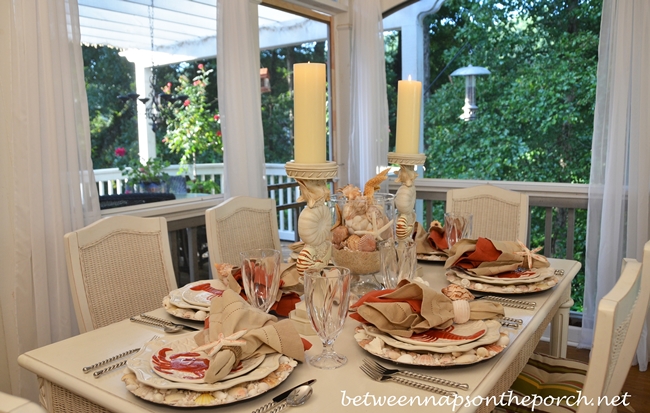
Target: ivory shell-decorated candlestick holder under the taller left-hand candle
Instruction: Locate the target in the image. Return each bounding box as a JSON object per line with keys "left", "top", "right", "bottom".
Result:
{"left": 284, "top": 161, "right": 338, "bottom": 275}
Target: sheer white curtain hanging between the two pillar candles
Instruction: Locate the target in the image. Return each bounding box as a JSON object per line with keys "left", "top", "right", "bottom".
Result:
{"left": 348, "top": 0, "right": 388, "bottom": 188}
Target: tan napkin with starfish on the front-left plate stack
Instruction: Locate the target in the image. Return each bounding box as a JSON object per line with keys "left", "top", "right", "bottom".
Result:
{"left": 194, "top": 290, "right": 305, "bottom": 383}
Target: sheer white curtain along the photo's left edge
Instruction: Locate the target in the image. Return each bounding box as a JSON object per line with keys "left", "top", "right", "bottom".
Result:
{"left": 0, "top": 0, "right": 99, "bottom": 400}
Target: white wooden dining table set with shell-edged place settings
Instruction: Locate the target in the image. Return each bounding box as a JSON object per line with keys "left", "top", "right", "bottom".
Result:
{"left": 18, "top": 259, "right": 580, "bottom": 413}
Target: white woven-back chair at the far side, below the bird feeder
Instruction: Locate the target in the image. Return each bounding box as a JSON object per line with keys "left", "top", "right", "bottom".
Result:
{"left": 445, "top": 184, "right": 529, "bottom": 243}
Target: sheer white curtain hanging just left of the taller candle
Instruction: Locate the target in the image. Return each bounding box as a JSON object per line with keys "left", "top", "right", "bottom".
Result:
{"left": 217, "top": 0, "right": 268, "bottom": 198}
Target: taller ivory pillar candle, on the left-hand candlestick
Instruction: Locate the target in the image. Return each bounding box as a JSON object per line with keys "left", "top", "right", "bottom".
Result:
{"left": 293, "top": 63, "right": 326, "bottom": 163}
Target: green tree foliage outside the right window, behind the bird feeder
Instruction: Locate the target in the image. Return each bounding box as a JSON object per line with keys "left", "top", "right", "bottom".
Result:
{"left": 410, "top": 0, "right": 602, "bottom": 309}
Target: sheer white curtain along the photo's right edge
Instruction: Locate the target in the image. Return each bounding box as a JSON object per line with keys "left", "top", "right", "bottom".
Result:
{"left": 580, "top": 0, "right": 650, "bottom": 371}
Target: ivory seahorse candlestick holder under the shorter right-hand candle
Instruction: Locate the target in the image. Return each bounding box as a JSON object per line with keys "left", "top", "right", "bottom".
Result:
{"left": 388, "top": 152, "right": 426, "bottom": 242}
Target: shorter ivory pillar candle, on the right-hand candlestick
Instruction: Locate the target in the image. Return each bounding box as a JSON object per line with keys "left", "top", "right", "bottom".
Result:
{"left": 395, "top": 75, "right": 422, "bottom": 154}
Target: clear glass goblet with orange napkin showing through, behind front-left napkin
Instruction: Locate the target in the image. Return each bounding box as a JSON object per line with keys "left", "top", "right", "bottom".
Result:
{"left": 239, "top": 249, "right": 282, "bottom": 313}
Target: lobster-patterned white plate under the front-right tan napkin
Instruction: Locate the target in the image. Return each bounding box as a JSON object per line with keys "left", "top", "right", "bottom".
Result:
{"left": 390, "top": 320, "right": 487, "bottom": 347}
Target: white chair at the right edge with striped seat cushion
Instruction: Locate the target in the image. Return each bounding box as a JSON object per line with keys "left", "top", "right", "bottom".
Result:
{"left": 495, "top": 242, "right": 650, "bottom": 413}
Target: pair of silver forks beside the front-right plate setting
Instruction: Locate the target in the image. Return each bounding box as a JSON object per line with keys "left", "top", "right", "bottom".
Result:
{"left": 359, "top": 358, "right": 469, "bottom": 396}
